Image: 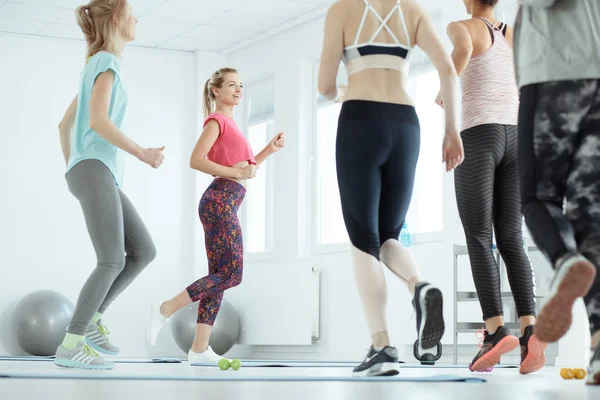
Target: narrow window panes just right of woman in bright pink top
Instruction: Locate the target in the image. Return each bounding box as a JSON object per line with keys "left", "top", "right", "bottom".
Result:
{"left": 242, "top": 82, "right": 274, "bottom": 253}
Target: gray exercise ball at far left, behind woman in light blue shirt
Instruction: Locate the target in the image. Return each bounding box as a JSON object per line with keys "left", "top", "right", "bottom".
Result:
{"left": 13, "top": 290, "right": 74, "bottom": 356}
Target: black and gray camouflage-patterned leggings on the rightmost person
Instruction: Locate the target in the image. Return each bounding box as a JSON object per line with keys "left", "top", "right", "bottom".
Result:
{"left": 519, "top": 80, "right": 600, "bottom": 335}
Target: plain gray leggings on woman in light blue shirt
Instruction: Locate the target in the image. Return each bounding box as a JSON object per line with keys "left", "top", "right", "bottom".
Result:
{"left": 66, "top": 160, "right": 156, "bottom": 335}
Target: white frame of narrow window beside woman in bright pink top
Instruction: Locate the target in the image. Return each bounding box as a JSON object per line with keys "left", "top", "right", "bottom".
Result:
{"left": 241, "top": 78, "right": 275, "bottom": 262}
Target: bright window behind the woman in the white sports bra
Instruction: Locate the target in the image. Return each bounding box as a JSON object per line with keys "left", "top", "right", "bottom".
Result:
{"left": 314, "top": 67, "right": 444, "bottom": 246}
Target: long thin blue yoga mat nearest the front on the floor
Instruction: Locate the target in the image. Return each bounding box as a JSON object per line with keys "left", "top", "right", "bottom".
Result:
{"left": 0, "top": 371, "right": 486, "bottom": 383}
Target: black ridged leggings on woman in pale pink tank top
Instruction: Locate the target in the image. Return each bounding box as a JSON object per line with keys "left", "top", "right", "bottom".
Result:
{"left": 454, "top": 124, "right": 535, "bottom": 320}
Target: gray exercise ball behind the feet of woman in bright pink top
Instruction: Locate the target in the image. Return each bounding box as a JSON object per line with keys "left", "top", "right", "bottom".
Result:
{"left": 171, "top": 299, "right": 241, "bottom": 356}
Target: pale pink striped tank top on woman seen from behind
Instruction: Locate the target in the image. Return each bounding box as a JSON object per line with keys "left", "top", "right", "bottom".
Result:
{"left": 460, "top": 18, "right": 519, "bottom": 131}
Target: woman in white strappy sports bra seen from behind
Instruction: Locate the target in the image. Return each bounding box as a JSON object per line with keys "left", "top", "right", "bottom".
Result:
{"left": 319, "top": 0, "right": 463, "bottom": 376}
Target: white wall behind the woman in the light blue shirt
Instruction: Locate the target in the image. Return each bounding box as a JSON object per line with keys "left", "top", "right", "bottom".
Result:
{"left": 0, "top": 34, "right": 197, "bottom": 357}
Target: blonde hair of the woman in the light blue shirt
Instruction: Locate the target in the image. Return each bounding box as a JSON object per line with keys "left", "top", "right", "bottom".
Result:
{"left": 75, "top": 0, "right": 129, "bottom": 58}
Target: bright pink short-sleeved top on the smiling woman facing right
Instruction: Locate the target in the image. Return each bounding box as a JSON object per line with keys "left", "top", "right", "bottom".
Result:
{"left": 204, "top": 113, "right": 256, "bottom": 167}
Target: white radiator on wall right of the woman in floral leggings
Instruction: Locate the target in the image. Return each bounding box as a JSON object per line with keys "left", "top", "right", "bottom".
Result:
{"left": 225, "top": 261, "right": 321, "bottom": 346}
